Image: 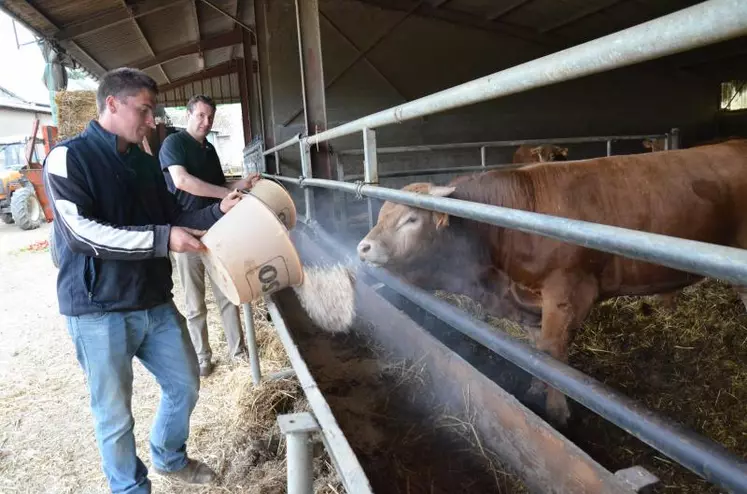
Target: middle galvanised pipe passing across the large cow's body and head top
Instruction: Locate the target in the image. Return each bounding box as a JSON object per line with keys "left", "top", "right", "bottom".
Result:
{"left": 268, "top": 177, "right": 747, "bottom": 286}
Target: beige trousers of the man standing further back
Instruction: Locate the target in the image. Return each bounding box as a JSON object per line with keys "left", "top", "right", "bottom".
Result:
{"left": 173, "top": 253, "right": 246, "bottom": 362}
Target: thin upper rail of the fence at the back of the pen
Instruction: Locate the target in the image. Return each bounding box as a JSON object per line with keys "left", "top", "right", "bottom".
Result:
{"left": 336, "top": 134, "right": 667, "bottom": 156}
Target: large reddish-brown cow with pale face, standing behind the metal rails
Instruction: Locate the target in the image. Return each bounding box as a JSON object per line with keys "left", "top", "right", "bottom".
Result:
{"left": 358, "top": 140, "right": 747, "bottom": 425}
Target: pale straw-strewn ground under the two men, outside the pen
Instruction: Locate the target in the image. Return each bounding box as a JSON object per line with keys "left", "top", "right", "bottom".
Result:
{"left": 0, "top": 224, "right": 342, "bottom": 494}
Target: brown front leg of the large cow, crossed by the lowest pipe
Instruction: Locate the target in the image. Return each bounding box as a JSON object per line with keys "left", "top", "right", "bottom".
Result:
{"left": 537, "top": 271, "right": 599, "bottom": 426}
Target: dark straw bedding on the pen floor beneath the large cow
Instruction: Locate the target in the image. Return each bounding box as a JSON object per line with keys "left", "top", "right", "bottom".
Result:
{"left": 438, "top": 280, "right": 747, "bottom": 493}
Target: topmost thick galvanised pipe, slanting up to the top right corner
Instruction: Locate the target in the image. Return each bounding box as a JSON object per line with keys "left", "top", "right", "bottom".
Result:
{"left": 308, "top": 0, "right": 747, "bottom": 144}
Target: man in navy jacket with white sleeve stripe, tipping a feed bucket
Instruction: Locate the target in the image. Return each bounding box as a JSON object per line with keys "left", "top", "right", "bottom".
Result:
{"left": 44, "top": 68, "right": 240, "bottom": 494}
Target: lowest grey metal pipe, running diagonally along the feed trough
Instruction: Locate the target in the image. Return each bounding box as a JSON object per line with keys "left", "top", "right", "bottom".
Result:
{"left": 307, "top": 222, "right": 747, "bottom": 492}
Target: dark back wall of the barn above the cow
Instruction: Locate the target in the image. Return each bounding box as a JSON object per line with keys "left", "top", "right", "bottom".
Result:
{"left": 268, "top": 0, "right": 719, "bottom": 173}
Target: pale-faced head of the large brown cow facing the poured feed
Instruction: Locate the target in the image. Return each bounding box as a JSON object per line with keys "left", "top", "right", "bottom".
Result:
{"left": 358, "top": 183, "right": 454, "bottom": 266}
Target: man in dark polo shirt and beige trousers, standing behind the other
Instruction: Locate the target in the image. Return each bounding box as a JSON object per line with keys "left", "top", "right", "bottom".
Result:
{"left": 158, "top": 95, "right": 259, "bottom": 376}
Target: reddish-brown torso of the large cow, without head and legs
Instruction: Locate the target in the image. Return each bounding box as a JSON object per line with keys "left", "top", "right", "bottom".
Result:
{"left": 452, "top": 140, "right": 747, "bottom": 295}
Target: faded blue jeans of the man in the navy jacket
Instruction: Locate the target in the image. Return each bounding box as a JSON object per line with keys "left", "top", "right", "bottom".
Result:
{"left": 67, "top": 303, "right": 200, "bottom": 494}
